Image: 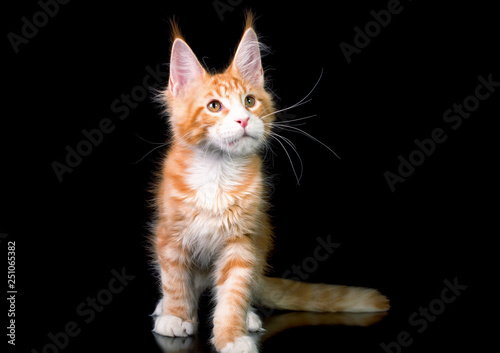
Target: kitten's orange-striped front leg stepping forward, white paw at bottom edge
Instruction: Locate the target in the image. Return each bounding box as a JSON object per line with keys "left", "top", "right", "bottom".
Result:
{"left": 212, "top": 236, "right": 258, "bottom": 353}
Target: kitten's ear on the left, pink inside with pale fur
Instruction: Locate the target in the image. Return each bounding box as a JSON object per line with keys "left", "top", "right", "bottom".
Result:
{"left": 168, "top": 38, "right": 206, "bottom": 97}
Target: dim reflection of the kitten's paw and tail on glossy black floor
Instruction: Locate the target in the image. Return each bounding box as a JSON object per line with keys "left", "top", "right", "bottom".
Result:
{"left": 154, "top": 312, "right": 387, "bottom": 353}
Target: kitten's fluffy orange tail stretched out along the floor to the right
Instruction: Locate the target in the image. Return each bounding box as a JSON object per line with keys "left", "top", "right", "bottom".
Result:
{"left": 256, "top": 277, "right": 390, "bottom": 312}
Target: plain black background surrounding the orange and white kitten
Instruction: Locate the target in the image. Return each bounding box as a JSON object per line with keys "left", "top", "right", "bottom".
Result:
{"left": 0, "top": 1, "right": 500, "bottom": 352}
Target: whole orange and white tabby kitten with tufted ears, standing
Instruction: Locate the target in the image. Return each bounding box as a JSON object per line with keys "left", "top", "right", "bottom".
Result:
{"left": 153, "top": 16, "right": 389, "bottom": 353}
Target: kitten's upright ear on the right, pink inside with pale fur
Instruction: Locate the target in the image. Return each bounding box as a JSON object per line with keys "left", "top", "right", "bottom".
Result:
{"left": 231, "top": 27, "right": 264, "bottom": 86}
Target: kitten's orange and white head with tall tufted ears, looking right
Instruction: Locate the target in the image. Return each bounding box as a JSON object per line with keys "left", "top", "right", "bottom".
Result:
{"left": 162, "top": 17, "right": 274, "bottom": 156}
